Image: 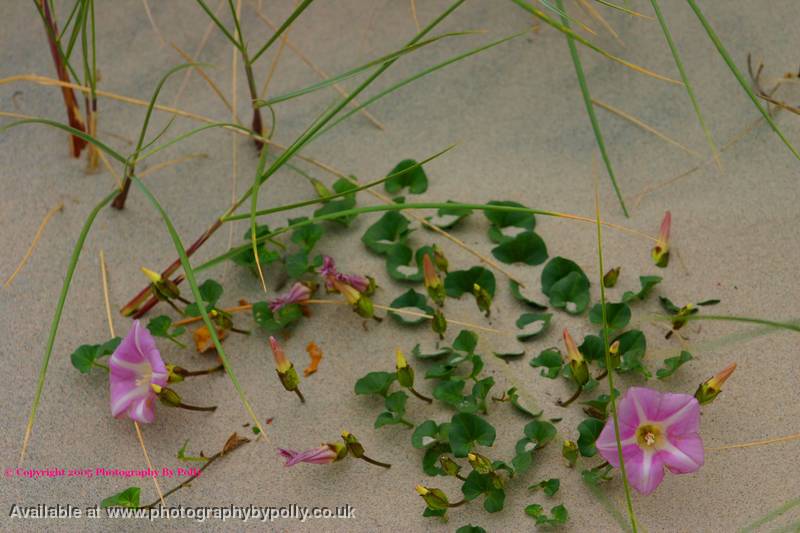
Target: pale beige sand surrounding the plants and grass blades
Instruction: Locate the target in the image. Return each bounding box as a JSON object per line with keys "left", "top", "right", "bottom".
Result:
{"left": 0, "top": 0, "right": 800, "bottom": 531}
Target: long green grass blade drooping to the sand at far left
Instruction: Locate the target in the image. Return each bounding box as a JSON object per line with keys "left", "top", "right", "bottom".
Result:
{"left": 19, "top": 190, "right": 117, "bottom": 464}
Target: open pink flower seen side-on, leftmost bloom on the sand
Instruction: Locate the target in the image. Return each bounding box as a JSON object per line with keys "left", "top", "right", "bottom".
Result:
{"left": 108, "top": 320, "right": 168, "bottom": 424}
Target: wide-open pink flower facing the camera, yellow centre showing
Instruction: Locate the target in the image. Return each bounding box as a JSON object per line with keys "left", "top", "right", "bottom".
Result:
{"left": 595, "top": 387, "right": 704, "bottom": 494}
